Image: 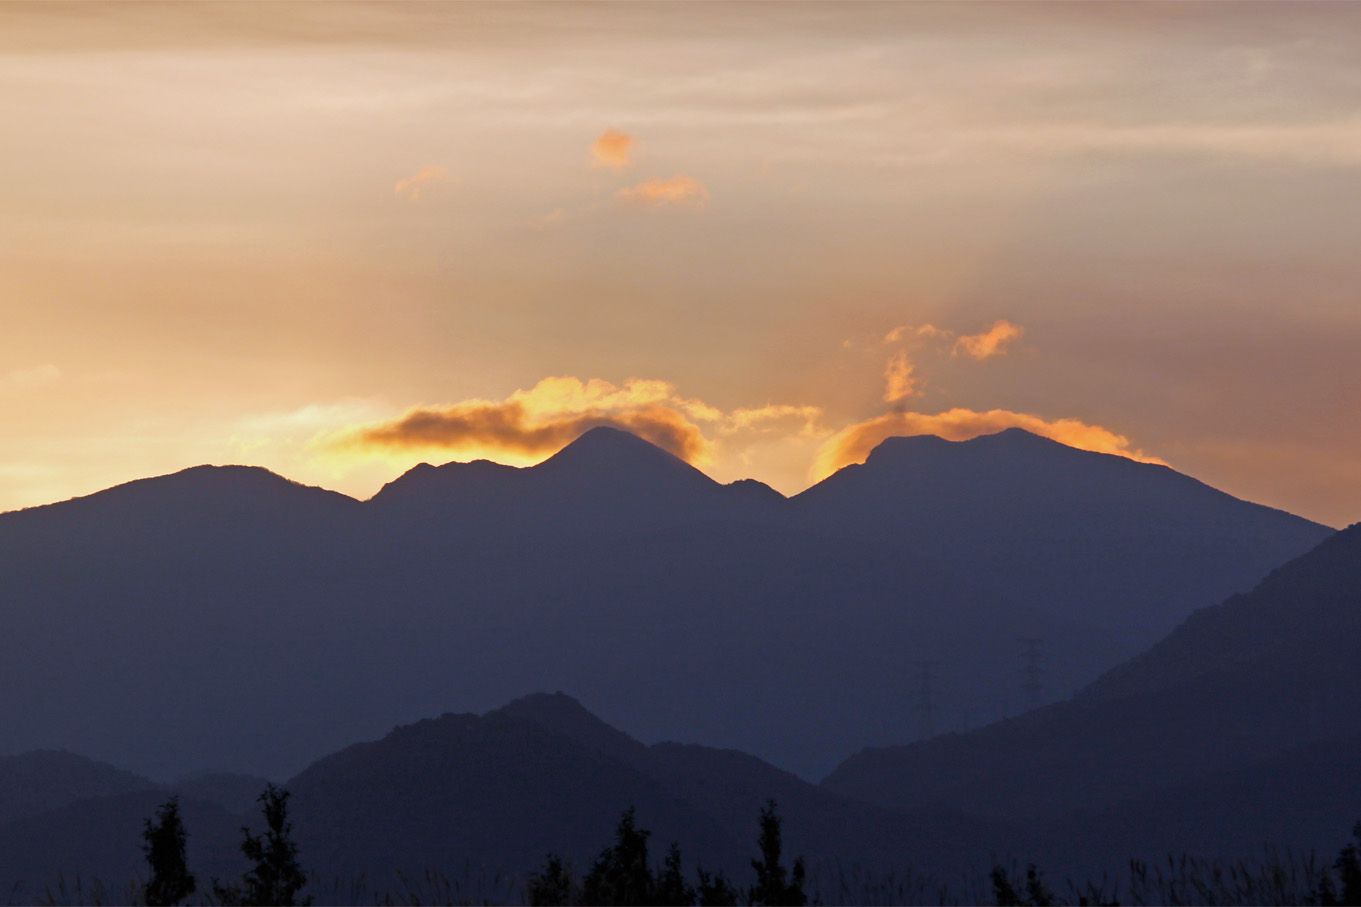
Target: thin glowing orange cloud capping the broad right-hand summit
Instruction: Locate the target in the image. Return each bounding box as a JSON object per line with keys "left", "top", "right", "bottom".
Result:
{"left": 811, "top": 409, "right": 1162, "bottom": 482}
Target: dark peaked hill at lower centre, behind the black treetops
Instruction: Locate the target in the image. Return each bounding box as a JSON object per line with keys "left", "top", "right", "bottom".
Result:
{"left": 290, "top": 693, "right": 992, "bottom": 881}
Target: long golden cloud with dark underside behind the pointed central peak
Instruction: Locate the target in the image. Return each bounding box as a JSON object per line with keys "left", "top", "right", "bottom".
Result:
{"left": 328, "top": 376, "right": 723, "bottom": 464}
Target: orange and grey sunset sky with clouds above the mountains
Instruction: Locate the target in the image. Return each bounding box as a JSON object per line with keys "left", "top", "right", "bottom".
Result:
{"left": 0, "top": 3, "right": 1361, "bottom": 526}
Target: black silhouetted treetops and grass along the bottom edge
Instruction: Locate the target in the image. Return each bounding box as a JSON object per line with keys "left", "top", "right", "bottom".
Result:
{"left": 11, "top": 784, "right": 1361, "bottom": 907}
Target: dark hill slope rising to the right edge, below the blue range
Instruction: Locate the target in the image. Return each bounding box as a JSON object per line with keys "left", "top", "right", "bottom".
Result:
{"left": 825, "top": 514, "right": 1361, "bottom": 873}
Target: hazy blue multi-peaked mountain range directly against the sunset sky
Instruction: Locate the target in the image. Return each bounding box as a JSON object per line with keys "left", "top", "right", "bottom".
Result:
{"left": 0, "top": 429, "right": 1330, "bottom": 778}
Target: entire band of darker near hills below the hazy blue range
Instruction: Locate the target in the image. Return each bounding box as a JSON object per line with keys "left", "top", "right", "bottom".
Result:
{"left": 0, "top": 512, "right": 1361, "bottom": 903}
